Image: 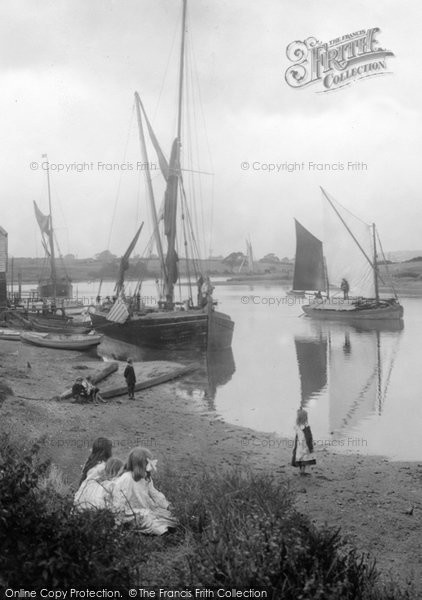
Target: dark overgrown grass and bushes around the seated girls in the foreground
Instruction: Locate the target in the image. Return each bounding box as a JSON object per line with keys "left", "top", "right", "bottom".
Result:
{"left": 0, "top": 436, "right": 412, "bottom": 600}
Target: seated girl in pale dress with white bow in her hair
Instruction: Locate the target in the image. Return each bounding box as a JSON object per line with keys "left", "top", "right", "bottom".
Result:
{"left": 112, "top": 447, "right": 177, "bottom": 535}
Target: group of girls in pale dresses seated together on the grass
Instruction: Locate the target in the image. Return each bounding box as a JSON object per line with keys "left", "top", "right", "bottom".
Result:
{"left": 75, "top": 437, "right": 177, "bottom": 535}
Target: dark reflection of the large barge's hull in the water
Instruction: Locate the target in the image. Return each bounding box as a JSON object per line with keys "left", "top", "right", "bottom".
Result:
{"left": 97, "top": 337, "right": 236, "bottom": 410}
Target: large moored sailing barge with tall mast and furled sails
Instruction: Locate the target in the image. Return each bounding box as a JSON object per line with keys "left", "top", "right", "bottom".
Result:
{"left": 91, "top": 0, "right": 234, "bottom": 349}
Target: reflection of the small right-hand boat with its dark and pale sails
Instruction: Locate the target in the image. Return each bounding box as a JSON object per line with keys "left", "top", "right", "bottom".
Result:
{"left": 295, "top": 320, "right": 403, "bottom": 438}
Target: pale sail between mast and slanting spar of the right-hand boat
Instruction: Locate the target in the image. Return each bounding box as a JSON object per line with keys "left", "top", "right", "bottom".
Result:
{"left": 323, "top": 191, "right": 375, "bottom": 298}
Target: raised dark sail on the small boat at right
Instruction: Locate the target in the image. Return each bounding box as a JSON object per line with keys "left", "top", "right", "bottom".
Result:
{"left": 293, "top": 219, "right": 327, "bottom": 291}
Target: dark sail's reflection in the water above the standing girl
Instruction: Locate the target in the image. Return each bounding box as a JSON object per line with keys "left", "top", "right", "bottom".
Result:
{"left": 295, "top": 337, "right": 327, "bottom": 408}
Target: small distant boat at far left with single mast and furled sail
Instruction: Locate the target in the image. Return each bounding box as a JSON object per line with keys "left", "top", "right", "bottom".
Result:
{"left": 34, "top": 155, "right": 73, "bottom": 299}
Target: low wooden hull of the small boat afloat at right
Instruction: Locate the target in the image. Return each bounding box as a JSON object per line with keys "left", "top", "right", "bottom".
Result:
{"left": 302, "top": 302, "right": 403, "bottom": 321}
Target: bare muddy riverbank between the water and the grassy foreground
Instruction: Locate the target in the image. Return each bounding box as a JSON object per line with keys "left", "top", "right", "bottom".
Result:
{"left": 0, "top": 341, "right": 422, "bottom": 597}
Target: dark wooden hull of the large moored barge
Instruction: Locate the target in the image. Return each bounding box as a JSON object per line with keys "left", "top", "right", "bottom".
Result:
{"left": 91, "top": 309, "right": 234, "bottom": 350}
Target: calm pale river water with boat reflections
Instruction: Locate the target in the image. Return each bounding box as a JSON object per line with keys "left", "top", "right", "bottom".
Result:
{"left": 27, "top": 282, "right": 422, "bottom": 461}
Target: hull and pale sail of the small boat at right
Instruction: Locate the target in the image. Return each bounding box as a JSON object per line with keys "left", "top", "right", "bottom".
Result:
{"left": 302, "top": 188, "right": 403, "bottom": 322}
